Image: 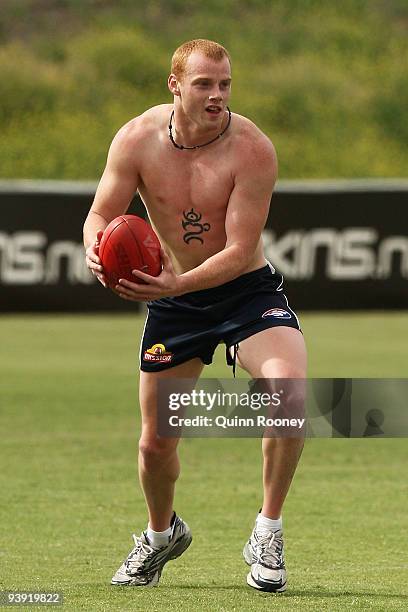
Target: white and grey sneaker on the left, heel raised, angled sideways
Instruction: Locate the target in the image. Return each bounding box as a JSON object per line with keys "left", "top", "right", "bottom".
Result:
{"left": 111, "top": 513, "right": 192, "bottom": 587}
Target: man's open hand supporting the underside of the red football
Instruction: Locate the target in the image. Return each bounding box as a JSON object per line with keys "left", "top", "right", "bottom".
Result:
{"left": 115, "top": 249, "right": 186, "bottom": 302}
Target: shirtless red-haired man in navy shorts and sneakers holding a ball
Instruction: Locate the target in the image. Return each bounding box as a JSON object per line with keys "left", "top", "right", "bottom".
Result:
{"left": 84, "top": 40, "right": 306, "bottom": 592}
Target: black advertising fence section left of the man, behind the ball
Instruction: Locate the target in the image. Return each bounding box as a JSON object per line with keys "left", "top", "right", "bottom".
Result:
{"left": 0, "top": 181, "right": 143, "bottom": 311}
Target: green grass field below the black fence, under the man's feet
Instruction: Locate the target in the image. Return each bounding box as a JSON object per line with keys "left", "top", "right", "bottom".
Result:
{"left": 0, "top": 313, "right": 408, "bottom": 612}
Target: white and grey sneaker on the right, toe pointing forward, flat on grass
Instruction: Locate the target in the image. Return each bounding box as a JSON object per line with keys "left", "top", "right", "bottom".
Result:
{"left": 243, "top": 526, "right": 286, "bottom": 593}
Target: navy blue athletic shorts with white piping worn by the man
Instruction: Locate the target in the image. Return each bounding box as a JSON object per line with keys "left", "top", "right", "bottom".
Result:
{"left": 140, "top": 264, "right": 300, "bottom": 373}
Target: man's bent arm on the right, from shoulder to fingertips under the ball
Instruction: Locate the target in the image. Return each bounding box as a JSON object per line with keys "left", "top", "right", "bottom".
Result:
{"left": 118, "top": 137, "right": 277, "bottom": 300}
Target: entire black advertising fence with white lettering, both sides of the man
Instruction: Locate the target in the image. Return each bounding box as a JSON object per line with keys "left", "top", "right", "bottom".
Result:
{"left": 0, "top": 180, "right": 408, "bottom": 312}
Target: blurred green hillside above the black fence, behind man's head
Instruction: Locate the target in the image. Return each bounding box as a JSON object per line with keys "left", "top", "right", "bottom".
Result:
{"left": 0, "top": 0, "right": 408, "bottom": 179}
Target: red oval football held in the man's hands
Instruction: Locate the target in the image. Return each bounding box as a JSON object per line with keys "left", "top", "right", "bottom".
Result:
{"left": 99, "top": 215, "right": 162, "bottom": 288}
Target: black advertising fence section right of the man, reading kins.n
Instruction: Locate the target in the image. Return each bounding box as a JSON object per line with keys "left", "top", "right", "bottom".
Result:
{"left": 265, "top": 180, "right": 408, "bottom": 310}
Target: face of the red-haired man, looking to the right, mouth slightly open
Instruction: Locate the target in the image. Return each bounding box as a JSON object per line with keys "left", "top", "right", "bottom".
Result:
{"left": 178, "top": 52, "right": 231, "bottom": 129}
